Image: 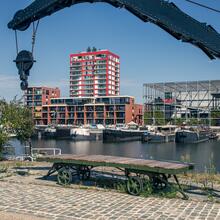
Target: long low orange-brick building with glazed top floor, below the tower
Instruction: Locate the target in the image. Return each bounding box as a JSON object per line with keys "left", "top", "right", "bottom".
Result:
{"left": 37, "top": 96, "right": 142, "bottom": 125}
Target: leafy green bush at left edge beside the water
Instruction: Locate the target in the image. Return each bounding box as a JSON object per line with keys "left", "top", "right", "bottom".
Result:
{"left": 0, "top": 99, "right": 34, "bottom": 158}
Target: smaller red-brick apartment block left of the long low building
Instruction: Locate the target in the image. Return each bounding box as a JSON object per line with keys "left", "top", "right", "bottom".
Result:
{"left": 25, "top": 86, "right": 60, "bottom": 124}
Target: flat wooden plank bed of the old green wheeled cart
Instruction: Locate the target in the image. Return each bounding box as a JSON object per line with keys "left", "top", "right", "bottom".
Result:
{"left": 38, "top": 154, "right": 193, "bottom": 175}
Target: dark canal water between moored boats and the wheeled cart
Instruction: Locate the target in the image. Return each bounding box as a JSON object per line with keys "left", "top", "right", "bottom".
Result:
{"left": 10, "top": 139, "right": 220, "bottom": 172}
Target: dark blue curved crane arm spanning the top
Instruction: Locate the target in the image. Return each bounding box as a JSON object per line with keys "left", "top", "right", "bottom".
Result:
{"left": 8, "top": 0, "right": 220, "bottom": 59}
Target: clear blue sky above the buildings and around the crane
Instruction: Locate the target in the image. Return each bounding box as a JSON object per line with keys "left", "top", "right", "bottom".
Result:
{"left": 0, "top": 0, "right": 220, "bottom": 103}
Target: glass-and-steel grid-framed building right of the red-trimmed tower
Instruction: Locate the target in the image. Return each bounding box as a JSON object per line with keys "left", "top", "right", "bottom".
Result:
{"left": 144, "top": 80, "right": 220, "bottom": 126}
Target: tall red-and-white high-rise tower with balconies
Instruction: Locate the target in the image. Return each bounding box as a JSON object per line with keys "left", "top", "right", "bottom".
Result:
{"left": 70, "top": 48, "right": 120, "bottom": 97}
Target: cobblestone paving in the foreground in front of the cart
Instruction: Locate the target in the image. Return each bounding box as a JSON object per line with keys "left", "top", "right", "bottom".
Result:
{"left": 0, "top": 162, "right": 220, "bottom": 220}
